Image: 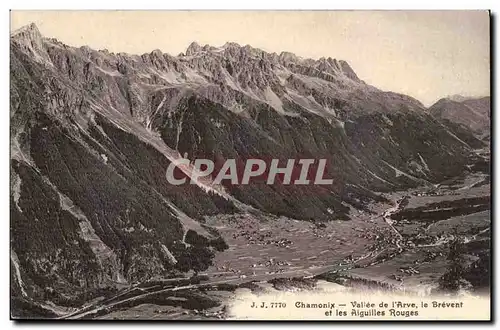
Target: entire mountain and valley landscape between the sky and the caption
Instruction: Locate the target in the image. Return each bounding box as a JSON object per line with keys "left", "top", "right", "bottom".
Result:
{"left": 10, "top": 24, "right": 491, "bottom": 319}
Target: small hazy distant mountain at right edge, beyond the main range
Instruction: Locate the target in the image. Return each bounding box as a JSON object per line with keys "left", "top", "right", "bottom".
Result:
{"left": 429, "top": 96, "right": 491, "bottom": 134}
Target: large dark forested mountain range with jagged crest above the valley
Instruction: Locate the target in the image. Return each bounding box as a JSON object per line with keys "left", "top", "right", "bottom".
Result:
{"left": 10, "top": 25, "right": 484, "bottom": 312}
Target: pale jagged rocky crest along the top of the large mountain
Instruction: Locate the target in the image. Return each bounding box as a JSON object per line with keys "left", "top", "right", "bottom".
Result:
{"left": 11, "top": 25, "right": 372, "bottom": 117}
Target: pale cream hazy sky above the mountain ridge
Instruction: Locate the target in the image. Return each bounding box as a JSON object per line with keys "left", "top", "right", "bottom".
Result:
{"left": 11, "top": 11, "right": 490, "bottom": 105}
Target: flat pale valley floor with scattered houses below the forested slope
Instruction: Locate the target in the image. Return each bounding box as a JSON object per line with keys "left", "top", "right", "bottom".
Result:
{"left": 48, "top": 160, "right": 491, "bottom": 320}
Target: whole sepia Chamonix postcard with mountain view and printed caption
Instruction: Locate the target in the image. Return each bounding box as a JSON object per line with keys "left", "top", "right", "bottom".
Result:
{"left": 10, "top": 10, "right": 492, "bottom": 321}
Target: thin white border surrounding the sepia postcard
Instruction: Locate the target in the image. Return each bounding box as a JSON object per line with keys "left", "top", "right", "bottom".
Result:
{"left": 0, "top": 0, "right": 500, "bottom": 329}
